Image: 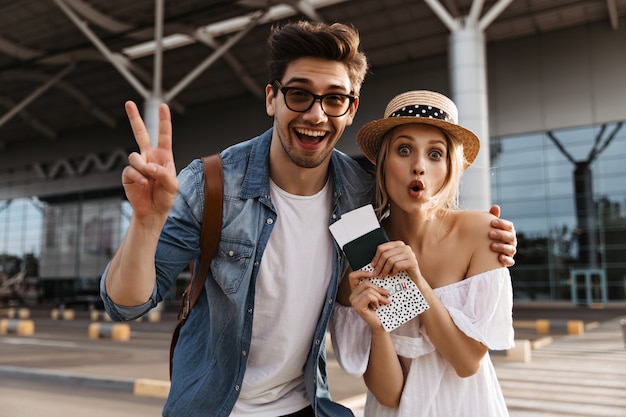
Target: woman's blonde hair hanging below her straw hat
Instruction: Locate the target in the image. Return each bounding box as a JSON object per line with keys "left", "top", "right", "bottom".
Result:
{"left": 375, "top": 124, "right": 466, "bottom": 218}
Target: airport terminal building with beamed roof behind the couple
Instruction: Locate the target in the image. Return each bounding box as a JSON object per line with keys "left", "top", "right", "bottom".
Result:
{"left": 0, "top": 0, "right": 626, "bottom": 305}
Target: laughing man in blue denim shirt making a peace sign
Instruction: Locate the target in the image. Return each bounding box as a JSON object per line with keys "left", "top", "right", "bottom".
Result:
{"left": 102, "top": 22, "right": 515, "bottom": 417}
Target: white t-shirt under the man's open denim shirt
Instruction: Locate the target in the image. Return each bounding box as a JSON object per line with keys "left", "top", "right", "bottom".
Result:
{"left": 231, "top": 177, "right": 333, "bottom": 417}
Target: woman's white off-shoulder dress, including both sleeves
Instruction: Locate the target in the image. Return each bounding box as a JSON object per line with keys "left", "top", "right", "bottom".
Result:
{"left": 330, "top": 268, "right": 514, "bottom": 417}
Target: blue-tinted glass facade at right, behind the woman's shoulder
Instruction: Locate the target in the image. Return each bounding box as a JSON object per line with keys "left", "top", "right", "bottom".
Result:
{"left": 490, "top": 123, "right": 626, "bottom": 304}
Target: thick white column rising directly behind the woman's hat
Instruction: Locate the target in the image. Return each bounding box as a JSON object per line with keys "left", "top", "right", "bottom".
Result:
{"left": 449, "top": 25, "right": 492, "bottom": 211}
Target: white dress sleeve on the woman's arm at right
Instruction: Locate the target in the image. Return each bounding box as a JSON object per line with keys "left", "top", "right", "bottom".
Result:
{"left": 435, "top": 268, "right": 514, "bottom": 350}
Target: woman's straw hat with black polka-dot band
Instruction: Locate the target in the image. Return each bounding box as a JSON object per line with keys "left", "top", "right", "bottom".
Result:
{"left": 356, "top": 90, "right": 480, "bottom": 168}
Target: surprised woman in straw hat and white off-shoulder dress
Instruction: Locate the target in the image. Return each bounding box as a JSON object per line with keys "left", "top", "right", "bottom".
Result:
{"left": 331, "top": 91, "right": 513, "bottom": 417}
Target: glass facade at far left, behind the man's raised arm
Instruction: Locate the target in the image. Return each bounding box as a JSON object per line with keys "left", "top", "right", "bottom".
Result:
{"left": 0, "top": 191, "right": 131, "bottom": 304}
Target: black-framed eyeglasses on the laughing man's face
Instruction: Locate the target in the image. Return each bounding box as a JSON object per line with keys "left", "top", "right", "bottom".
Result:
{"left": 274, "top": 80, "right": 356, "bottom": 117}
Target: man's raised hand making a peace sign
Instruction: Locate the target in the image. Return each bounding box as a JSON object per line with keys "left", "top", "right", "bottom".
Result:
{"left": 122, "top": 101, "right": 178, "bottom": 225}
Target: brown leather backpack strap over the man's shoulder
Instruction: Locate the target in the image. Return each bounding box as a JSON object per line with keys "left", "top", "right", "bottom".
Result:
{"left": 170, "top": 153, "right": 224, "bottom": 379}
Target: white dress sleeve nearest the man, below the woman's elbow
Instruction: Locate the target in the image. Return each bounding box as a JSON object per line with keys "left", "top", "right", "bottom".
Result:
{"left": 328, "top": 303, "right": 372, "bottom": 376}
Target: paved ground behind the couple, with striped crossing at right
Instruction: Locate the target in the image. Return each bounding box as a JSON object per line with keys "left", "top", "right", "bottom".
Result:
{"left": 0, "top": 303, "right": 626, "bottom": 417}
